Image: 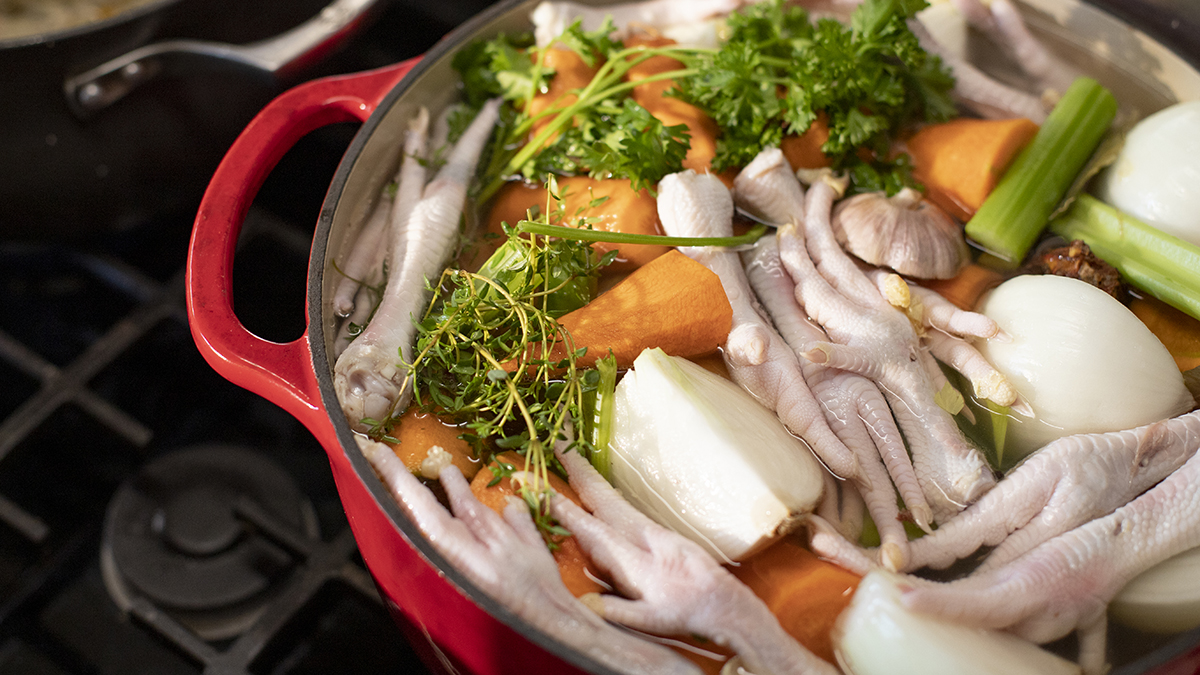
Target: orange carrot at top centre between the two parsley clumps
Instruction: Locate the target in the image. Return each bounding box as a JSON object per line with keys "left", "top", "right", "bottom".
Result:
{"left": 625, "top": 36, "right": 720, "bottom": 172}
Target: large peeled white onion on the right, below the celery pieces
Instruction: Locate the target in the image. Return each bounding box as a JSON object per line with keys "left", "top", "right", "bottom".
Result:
{"left": 976, "top": 275, "right": 1193, "bottom": 458}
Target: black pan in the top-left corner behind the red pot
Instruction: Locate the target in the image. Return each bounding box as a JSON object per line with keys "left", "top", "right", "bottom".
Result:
{"left": 0, "top": 0, "right": 376, "bottom": 238}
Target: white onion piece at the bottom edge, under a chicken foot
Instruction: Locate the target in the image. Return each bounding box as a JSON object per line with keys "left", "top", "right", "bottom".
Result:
{"left": 833, "top": 571, "right": 1080, "bottom": 675}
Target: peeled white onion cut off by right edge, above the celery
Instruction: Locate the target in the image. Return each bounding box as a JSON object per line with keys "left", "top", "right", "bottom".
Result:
{"left": 1097, "top": 101, "right": 1200, "bottom": 245}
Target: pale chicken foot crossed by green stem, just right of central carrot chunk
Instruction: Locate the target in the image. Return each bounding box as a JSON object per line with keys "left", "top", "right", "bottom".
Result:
{"left": 658, "top": 169, "right": 862, "bottom": 477}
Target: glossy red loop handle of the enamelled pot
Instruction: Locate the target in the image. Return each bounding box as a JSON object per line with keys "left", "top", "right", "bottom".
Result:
{"left": 185, "top": 59, "right": 419, "bottom": 447}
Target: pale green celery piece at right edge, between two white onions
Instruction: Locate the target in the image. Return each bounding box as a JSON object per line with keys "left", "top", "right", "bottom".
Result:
{"left": 1050, "top": 195, "right": 1200, "bottom": 318}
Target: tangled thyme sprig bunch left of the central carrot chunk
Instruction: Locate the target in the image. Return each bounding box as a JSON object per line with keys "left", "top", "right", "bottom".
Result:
{"left": 374, "top": 186, "right": 614, "bottom": 533}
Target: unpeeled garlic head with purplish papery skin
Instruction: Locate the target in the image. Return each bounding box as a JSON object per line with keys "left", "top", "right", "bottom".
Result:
{"left": 833, "top": 187, "right": 971, "bottom": 279}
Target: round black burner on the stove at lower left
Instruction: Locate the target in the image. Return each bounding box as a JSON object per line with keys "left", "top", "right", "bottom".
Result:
{"left": 101, "top": 446, "right": 319, "bottom": 640}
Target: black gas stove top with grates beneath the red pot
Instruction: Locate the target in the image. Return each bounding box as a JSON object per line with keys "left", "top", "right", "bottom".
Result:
{"left": 0, "top": 0, "right": 490, "bottom": 675}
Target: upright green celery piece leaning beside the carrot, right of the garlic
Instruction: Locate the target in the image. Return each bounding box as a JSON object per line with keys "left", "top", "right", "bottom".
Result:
{"left": 966, "top": 77, "right": 1117, "bottom": 265}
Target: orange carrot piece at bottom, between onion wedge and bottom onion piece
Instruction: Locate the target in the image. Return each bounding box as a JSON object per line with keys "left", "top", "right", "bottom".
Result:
{"left": 732, "top": 538, "right": 860, "bottom": 663}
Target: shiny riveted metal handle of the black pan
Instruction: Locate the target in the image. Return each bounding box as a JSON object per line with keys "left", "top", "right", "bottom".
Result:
{"left": 62, "top": 0, "right": 378, "bottom": 119}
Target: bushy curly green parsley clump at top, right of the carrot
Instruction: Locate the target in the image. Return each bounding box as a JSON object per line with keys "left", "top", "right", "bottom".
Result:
{"left": 677, "top": 0, "right": 956, "bottom": 191}
